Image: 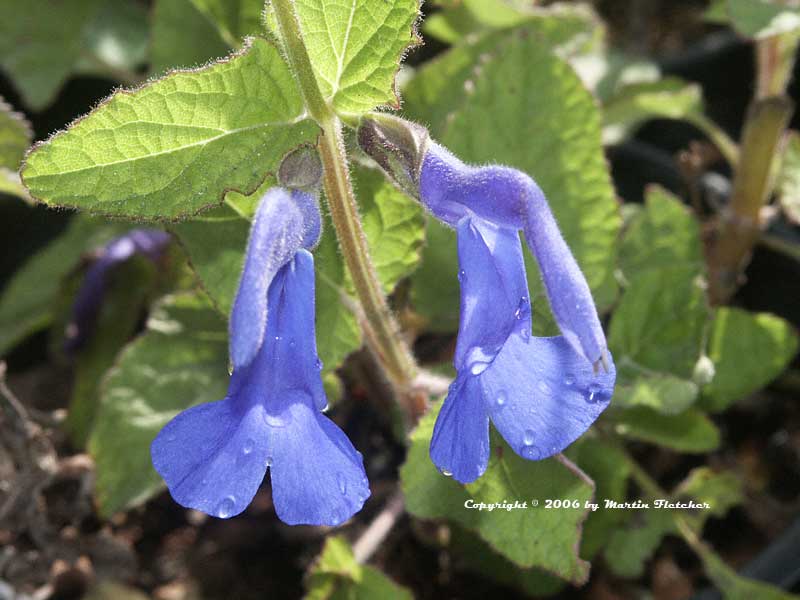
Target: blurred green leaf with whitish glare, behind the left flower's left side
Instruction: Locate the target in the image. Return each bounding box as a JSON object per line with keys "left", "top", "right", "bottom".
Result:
{"left": 89, "top": 295, "right": 228, "bottom": 517}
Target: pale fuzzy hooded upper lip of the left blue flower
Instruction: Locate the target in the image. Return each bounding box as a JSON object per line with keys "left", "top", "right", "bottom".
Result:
{"left": 230, "top": 188, "right": 304, "bottom": 369}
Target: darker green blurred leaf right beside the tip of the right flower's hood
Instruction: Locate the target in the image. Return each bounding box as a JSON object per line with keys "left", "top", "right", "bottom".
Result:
{"left": 608, "top": 264, "right": 709, "bottom": 379}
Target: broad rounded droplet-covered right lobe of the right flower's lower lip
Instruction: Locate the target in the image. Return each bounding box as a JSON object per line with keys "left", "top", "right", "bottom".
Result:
{"left": 480, "top": 332, "right": 616, "bottom": 460}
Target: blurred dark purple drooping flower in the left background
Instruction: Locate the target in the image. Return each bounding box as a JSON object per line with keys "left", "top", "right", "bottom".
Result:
{"left": 64, "top": 229, "right": 170, "bottom": 351}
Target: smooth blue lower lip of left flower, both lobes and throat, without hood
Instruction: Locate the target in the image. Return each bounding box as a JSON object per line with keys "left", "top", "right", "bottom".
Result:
{"left": 151, "top": 250, "right": 370, "bottom": 525}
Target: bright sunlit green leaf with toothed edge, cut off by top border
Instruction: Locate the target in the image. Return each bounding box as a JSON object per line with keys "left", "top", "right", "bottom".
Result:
{"left": 294, "top": 0, "right": 419, "bottom": 114}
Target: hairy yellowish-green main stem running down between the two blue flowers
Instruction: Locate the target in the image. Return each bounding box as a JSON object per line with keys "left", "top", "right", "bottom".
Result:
{"left": 272, "top": 0, "right": 419, "bottom": 408}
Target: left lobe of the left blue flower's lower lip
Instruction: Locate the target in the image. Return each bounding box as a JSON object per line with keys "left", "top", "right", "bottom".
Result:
{"left": 150, "top": 398, "right": 269, "bottom": 519}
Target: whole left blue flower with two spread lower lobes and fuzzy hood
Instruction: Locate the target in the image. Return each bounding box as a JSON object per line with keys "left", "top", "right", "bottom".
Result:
{"left": 151, "top": 188, "right": 370, "bottom": 525}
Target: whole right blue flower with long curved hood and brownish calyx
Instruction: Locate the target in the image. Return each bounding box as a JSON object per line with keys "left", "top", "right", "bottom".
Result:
{"left": 359, "top": 119, "right": 616, "bottom": 483}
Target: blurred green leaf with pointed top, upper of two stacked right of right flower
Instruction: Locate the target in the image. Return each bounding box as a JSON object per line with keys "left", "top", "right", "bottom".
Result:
{"left": 619, "top": 185, "right": 704, "bottom": 280}
